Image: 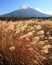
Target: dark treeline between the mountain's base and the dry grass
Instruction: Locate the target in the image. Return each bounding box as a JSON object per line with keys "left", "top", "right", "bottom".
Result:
{"left": 0, "top": 17, "right": 52, "bottom": 21}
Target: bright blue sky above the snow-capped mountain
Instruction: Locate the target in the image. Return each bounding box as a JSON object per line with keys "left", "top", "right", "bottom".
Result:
{"left": 0, "top": 0, "right": 52, "bottom": 15}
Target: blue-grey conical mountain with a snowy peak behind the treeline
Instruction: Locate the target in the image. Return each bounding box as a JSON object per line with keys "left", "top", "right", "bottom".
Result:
{"left": 1, "top": 7, "right": 49, "bottom": 18}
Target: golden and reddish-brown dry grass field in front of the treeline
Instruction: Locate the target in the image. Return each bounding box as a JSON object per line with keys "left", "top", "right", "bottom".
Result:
{"left": 0, "top": 19, "right": 52, "bottom": 65}
